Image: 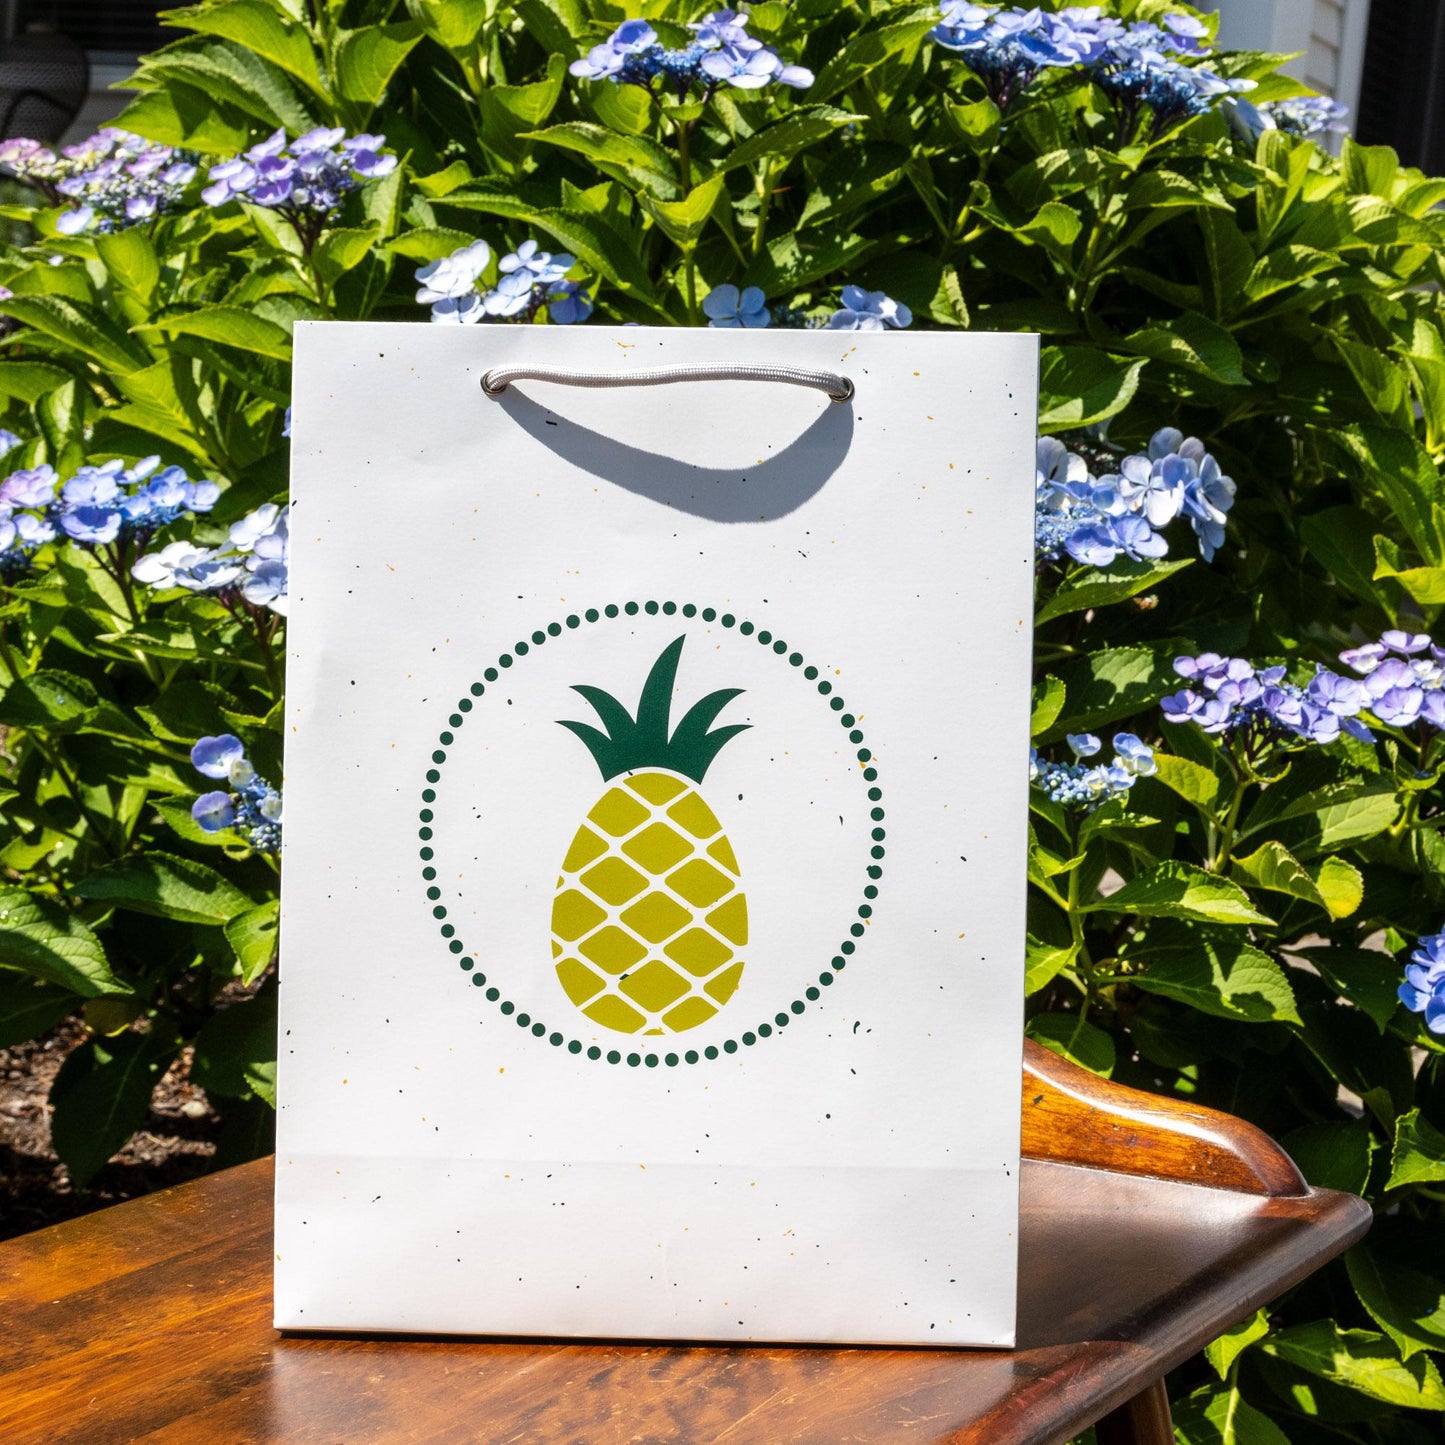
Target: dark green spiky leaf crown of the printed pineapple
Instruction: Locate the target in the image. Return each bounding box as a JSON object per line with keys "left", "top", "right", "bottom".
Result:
{"left": 558, "top": 637, "right": 750, "bottom": 783}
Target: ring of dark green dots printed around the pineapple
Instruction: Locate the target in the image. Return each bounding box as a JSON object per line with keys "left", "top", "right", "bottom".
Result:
{"left": 418, "top": 601, "right": 884, "bottom": 1069}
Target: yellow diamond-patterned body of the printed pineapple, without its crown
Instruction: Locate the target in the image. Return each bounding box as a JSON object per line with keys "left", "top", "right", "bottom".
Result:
{"left": 552, "top": 769, "right": 747, "bottom": 1033}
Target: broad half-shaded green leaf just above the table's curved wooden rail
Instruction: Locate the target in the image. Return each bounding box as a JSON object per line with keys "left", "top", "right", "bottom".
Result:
{"left": 1129, "top": 929, "right": 1299, "bottom": 1023}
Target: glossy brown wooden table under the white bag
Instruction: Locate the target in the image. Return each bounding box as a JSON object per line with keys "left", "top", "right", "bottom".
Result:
{"left": 0, "top": 1052, "right": 1370, "bottom": 1445}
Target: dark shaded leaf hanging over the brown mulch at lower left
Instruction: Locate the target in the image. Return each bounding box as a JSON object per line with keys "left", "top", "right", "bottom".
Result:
{"left": 51, "top": 1029, "right": 179, "bottom": 1188}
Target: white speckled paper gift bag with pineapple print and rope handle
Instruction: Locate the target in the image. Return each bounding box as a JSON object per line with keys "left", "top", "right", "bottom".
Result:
{"left": 276, "top": 322, "right": 1038, "bottom": 1345}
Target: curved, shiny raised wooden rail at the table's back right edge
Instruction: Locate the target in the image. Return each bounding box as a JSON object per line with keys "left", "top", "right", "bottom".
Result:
{"left": 1023, "top": 1039, "right": 1309, "bottom": 1198}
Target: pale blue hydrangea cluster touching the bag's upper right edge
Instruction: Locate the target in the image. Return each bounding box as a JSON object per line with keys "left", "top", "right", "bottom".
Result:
{"left": 1033, "top": 426, "right": 1235, "bottom": 566}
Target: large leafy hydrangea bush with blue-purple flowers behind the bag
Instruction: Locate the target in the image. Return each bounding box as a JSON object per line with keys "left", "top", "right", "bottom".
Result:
{"left": 0, "top": 0, "right": 1445, "bottom": 1445}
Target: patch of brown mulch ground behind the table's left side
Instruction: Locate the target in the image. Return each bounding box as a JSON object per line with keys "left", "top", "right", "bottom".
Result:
{"left": 0, "top": 1017, "right": 221, "bottom": 1240}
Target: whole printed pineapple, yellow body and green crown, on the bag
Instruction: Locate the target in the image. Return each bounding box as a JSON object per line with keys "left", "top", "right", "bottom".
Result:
{"left": 552, "top": 637, "right": 747, "bottom": 1035}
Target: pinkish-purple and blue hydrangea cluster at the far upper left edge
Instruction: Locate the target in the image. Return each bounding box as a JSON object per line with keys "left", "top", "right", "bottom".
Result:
{"left": 0, "top": 126, "right": 197, "bottom": 236}
